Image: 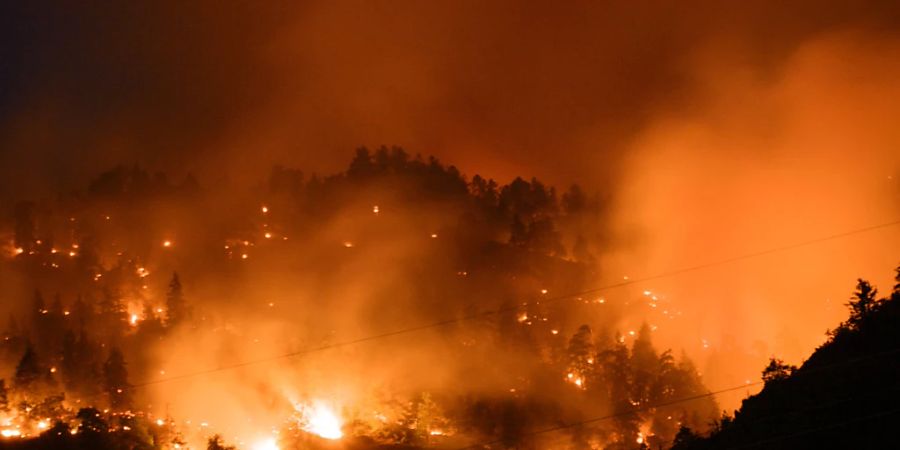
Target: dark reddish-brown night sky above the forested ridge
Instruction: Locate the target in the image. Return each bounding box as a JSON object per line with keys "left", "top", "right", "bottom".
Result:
{"left": 0, "top": 0, "right": 900, "bottom": 195}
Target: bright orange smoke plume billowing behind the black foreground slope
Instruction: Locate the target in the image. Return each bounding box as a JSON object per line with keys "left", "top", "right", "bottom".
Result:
{"left": 609, "top": 32, "right": 900, "bottom": 404}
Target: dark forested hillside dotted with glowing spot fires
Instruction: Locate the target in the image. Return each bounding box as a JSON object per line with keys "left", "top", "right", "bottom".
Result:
{"left": 0, "top": 147, "right": 718, "bottom": 449}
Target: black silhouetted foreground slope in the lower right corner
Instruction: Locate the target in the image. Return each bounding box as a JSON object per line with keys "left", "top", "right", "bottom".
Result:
{"left": 673, "top": 268, "right": 900, "bottom": 450}
